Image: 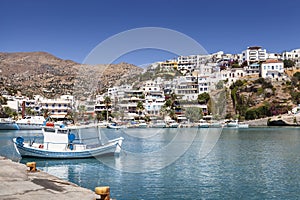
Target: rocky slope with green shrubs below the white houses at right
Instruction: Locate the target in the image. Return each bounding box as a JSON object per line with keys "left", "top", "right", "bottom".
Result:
{"left": 227, "top": 77, "right": 300, "bottom": 120}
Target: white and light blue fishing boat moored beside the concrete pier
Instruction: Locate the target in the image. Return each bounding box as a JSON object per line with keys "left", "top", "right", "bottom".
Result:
{"left": 13, "top": 122, "right": 124, "bottom": 159}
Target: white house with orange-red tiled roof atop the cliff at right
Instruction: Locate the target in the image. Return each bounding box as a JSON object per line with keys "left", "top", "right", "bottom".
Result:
{"left": 261, "top": 60, "right": 284, "bottom": 79}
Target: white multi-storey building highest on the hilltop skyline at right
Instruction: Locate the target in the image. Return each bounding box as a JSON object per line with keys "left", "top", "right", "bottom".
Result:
{"left": 242, "top": 46, "right": 267, "bottom": 63}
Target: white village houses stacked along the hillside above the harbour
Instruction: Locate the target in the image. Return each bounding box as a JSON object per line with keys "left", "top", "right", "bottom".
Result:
{"left": 3, "top": 46, "right": 300, "bottom": 122}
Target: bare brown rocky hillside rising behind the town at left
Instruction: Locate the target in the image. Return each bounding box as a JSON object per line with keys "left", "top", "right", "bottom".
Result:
{"left": 0, "top": 52, "right": 143, "bottom": 98}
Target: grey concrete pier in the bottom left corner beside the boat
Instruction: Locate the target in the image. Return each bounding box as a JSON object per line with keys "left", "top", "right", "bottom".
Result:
{"left": 0, "top": 156, "right": 99, "bottom": 200}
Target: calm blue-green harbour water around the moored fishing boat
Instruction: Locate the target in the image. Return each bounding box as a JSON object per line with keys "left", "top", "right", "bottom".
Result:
{"left": 0, "top": 128, "right": 300, "bottom": 199}
